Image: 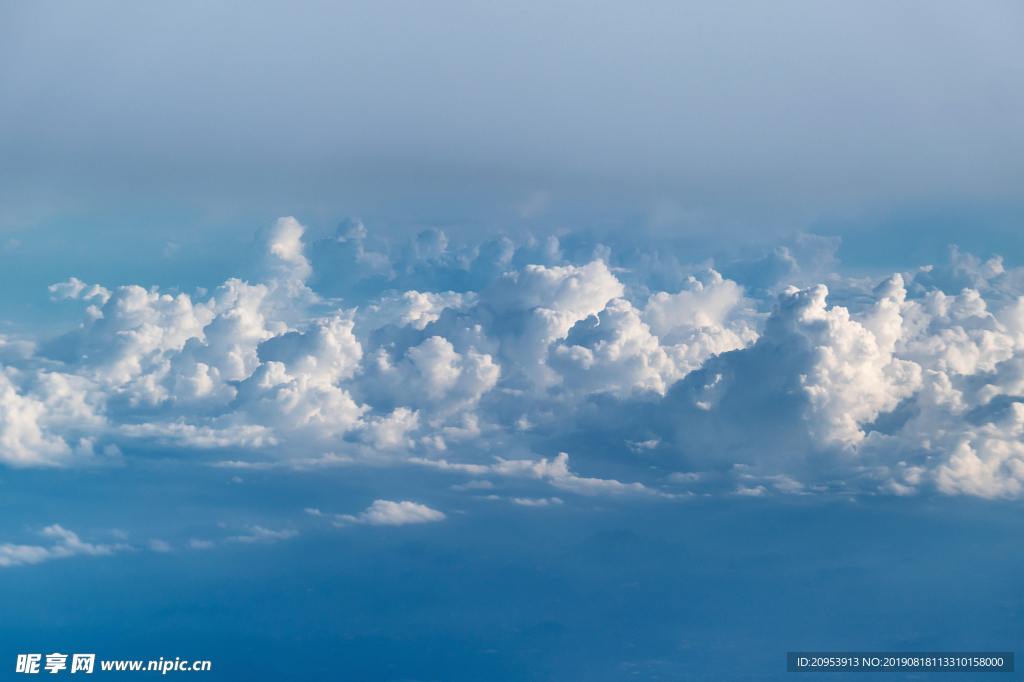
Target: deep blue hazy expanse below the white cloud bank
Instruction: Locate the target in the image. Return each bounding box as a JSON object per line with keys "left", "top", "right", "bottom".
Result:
{"left": 0, "top": 461, "right": 1024, "bottom": 682}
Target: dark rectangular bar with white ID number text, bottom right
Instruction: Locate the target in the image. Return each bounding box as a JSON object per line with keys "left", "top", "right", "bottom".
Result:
{"left": 785, "top": 651, "right": 1014, "bottom": 673}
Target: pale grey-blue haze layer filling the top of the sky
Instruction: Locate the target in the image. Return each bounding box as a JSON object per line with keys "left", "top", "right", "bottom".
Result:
{"left": 0, "top": 2, "right": 1024, "bottom": 215}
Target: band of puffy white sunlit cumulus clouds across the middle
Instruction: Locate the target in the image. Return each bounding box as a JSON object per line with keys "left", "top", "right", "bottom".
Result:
{"left": 6, "top": 218, "right": 1024, "bottom": 499}
